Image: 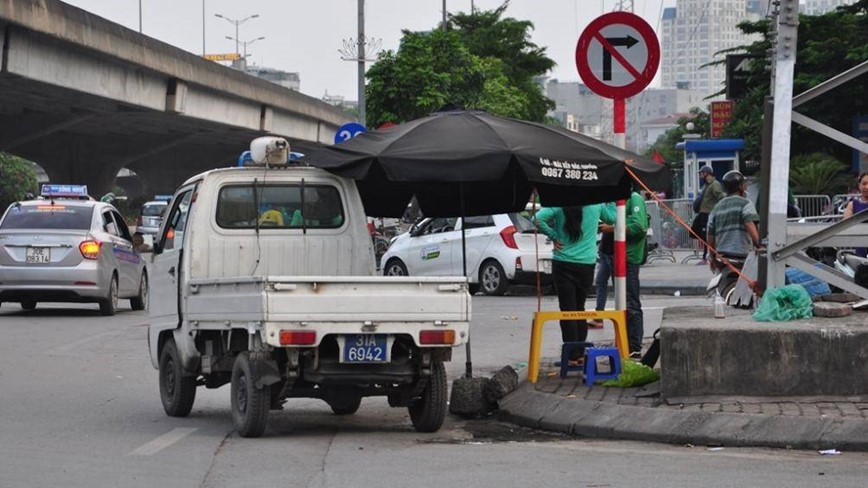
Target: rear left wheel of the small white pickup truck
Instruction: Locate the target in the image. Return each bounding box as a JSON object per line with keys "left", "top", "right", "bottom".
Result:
{"left": 231, "top": 351, "right": 271, "bottom": 437}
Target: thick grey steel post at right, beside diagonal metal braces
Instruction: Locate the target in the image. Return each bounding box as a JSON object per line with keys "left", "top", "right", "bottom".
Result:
{"left": 764, "top": 0, "right": 799, "bottom": 288}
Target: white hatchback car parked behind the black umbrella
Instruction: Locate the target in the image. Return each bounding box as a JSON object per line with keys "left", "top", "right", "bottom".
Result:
{"left": 382, "top": 213, "right": 552, "bottom": 295}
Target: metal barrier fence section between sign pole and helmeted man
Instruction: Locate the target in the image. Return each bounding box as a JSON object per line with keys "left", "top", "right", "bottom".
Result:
{"left": 646, "top": 198, "right": 702, "bottom": 264}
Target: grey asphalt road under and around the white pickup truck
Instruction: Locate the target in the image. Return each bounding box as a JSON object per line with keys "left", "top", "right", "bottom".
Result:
{"left": 0, "top": 296, "right": 868, "bottom": 488}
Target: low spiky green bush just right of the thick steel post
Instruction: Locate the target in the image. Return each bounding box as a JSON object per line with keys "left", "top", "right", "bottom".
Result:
{"left": 790, "top": 153, "right": 850, "bottom": 196}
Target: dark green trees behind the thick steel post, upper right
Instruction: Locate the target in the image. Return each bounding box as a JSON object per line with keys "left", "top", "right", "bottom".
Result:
{"left": 724, "top": 0, "right": 868, "bottom": 160}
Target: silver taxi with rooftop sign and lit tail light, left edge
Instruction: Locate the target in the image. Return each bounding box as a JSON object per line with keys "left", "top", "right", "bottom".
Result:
{"left": 0, "top": 185, "right": 148, "bottom": 315}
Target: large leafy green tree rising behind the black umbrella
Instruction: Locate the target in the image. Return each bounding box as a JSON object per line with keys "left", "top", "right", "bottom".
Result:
{"left": 366, "top": 3, "right": 554, "bottom": 127}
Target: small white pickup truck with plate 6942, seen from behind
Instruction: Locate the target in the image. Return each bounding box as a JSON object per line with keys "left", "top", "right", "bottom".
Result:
{"left": 148, "top": 138, "right": 470, "bottom": 437}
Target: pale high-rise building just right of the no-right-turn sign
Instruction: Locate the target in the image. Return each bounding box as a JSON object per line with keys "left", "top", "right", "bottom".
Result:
{"left": 660, "top": 0, "right": 763, "bottom": 96}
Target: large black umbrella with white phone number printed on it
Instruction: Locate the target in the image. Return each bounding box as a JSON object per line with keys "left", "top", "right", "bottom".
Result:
{"left": 304, "top": 110, "right": 670, "bottom": 217}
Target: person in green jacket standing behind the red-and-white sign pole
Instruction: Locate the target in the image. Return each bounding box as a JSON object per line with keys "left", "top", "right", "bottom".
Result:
{"left": 599, "top": 191, "right": 648, "bottom": 359}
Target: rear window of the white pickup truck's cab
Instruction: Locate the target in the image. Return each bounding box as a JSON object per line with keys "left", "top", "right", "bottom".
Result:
{"left": 217, "top": 183, "right": 344, "bottom": 230}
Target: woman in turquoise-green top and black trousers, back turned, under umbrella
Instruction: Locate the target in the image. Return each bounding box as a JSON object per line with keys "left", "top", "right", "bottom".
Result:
{"left": 536, "top": 205, "right": 601, "bottom": 366}
